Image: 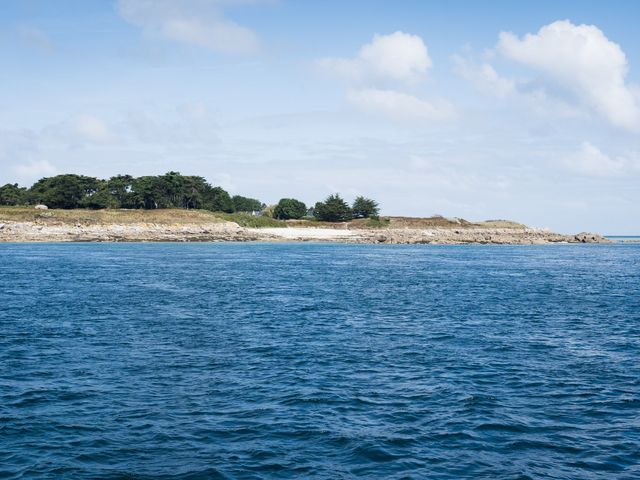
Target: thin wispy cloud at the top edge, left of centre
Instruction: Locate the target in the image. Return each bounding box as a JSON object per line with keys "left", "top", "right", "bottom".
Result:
{"left": 117, "top": 0, "right": 260, "bottom": 54}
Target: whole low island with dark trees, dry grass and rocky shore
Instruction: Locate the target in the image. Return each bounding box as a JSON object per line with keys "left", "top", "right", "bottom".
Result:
{"left": 0, "top": 172, "right": 609, "bottom": 245}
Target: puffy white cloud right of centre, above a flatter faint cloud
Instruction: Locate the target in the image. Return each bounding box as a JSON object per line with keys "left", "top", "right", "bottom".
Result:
{"left": 318, "top": 31, "right": 432, "bottom": 82}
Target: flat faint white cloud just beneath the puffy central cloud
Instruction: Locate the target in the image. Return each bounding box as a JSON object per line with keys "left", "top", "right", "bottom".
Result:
{"left": 347, "top": 88, "right": 456, "bottom": 121}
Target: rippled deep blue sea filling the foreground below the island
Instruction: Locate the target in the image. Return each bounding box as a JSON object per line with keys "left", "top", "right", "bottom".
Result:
{"left": 0, "top": 244, "right": 640, "bottom": 479}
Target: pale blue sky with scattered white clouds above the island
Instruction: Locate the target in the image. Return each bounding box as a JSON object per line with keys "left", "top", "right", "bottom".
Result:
{"left": 0, "top": 0, "right": 640, "bottom": 235}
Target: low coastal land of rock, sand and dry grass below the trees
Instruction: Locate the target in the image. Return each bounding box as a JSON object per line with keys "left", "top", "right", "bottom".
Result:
{"left": 0, "top": 208, "right": 609, "bottom": 245}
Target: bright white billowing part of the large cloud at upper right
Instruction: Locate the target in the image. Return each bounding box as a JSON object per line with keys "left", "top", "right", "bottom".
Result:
{"left": 497, "top": 20, "right": 640, "bottom": 131}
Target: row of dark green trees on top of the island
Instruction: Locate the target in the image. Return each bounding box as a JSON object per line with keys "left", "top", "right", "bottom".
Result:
{"left": 0, "top": 172, "right": 379, "bottom": 222}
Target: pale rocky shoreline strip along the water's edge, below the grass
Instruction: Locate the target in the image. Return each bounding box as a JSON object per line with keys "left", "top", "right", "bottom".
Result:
{"left": 0, "top": 221, "right": 611, "bottom": 245}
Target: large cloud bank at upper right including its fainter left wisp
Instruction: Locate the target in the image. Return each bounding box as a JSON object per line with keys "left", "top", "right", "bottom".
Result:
{"left": 453, "top": 20, "right": 640, "bottom": 133}
